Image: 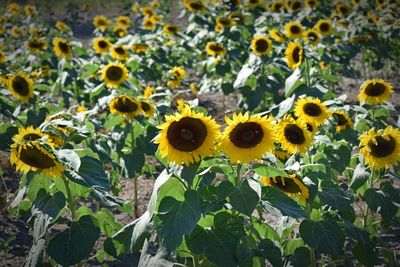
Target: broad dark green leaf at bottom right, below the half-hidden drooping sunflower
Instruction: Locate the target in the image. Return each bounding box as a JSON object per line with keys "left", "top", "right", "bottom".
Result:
{"left": 299, "top": 220, "right": 345, "bottom": 256}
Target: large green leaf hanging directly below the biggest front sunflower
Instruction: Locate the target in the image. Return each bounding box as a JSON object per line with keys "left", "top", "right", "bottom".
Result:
{"left": 155, "top": 190, "right": 201, "bottom": 253}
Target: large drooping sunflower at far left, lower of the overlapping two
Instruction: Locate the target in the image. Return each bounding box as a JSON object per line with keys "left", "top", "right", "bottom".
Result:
{"left": 10, "top": 140, "right": 64, "bottom": 177}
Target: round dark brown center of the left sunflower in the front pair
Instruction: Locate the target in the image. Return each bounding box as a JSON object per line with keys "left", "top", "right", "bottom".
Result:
{"left": 167, "top": 117, "right": 207, "bottom": 152}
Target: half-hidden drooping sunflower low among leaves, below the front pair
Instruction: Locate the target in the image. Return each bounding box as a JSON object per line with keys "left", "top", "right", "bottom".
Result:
{"left": 260, "top": 174, "right": 309, "bottom": 201}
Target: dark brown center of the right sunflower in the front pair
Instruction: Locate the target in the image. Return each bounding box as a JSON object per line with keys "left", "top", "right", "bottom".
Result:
{"left": 229, "top": 122, "right": 264, "bottom": 148}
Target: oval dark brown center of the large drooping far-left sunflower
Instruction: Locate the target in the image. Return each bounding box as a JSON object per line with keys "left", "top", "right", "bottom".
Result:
{"left": 19, "top": 146, "right": 56, "bottom": 169}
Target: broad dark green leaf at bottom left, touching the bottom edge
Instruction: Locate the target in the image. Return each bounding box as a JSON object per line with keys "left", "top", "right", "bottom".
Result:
{"left": 47, "top": 215, "right": 100, "bottom": 266}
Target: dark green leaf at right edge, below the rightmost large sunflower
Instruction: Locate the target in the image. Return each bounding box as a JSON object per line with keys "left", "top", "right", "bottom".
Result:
{"left": 364, "top": 188, "right": 398, "bottom": 225}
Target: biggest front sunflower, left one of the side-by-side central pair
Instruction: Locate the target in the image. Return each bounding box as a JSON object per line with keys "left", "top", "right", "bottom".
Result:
{"left": 154, "top": 106, "right": 221, "bottom": 165}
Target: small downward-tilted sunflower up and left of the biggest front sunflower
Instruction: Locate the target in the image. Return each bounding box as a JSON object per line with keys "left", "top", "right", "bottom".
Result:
{"left": 109, "top": 95, "right": 142, "bottom": 119}
